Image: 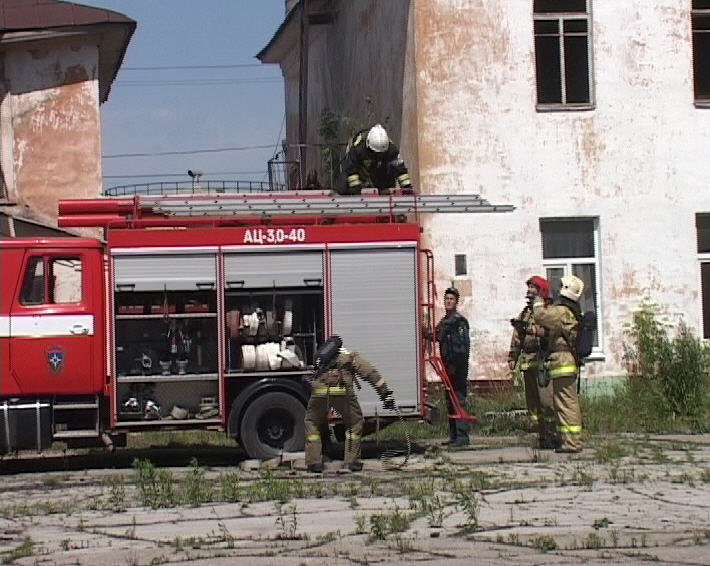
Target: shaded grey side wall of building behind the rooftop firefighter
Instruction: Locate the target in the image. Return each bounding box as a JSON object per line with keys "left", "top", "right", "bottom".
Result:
{"left": 280, "top": 0, "right": 416, "bottom": 191}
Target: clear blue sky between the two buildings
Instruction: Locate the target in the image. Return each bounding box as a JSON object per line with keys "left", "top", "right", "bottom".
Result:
{"left": 75, "top": 0, "right": 285, "bottom": 190}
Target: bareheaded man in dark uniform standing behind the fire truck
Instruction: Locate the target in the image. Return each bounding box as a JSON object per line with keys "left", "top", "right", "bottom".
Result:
{"left": 436, "top": 287, "right": 471, "bottom": 446}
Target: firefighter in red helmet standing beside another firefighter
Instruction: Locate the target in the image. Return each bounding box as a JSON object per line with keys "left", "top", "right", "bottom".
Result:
{"left": 508, "top": 275, "right": 557, "bottom": 449}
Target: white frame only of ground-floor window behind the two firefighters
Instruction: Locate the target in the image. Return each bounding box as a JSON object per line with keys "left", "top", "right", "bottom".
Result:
{"left": 539, "top": 216, "right": 606, "bottom": 361}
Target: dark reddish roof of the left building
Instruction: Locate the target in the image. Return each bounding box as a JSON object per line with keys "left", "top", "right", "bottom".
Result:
{"left": 0, "top": 0, "right": 136, "bottom": 102}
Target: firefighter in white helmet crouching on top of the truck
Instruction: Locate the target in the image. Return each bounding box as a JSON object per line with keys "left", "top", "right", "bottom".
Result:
{"left": 338, "top": 124, "right": 413, "bottom": 194}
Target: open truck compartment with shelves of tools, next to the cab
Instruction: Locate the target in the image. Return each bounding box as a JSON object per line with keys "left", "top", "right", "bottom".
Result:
{"left": 114, "top": 253, "right": 219, "bottom": 424}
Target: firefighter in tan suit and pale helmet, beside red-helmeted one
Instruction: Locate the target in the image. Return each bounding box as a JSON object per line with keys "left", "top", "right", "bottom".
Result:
{"left": 533, "top": 275, "right": 584, "bottom": 458}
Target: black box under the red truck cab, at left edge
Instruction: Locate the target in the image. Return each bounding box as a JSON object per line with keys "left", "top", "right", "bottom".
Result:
{"left": 0, "top": 401, "right": 52, "bottom": 453}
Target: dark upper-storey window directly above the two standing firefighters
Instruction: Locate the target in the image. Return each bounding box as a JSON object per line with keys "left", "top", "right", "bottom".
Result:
{"left": 533, "top": 0, "right": 592, "bottom": 109}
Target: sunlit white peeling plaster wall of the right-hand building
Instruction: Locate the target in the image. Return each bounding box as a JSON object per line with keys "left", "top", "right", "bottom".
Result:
{"left": 414, "top": 0, "right": 710, "bottom": 379}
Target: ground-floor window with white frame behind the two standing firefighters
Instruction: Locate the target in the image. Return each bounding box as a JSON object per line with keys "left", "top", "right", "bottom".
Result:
{"left": 540, "top": 218, "right": 602, "bottom": 351}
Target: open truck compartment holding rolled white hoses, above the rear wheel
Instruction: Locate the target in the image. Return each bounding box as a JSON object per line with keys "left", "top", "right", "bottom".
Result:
{"left": 224, "top": 249, "right": 323, "bottom": 375}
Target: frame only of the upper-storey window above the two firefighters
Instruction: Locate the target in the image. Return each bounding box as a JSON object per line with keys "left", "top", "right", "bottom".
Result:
{"left": 532, "top": 0, "right": 596, "bottom": 112}
